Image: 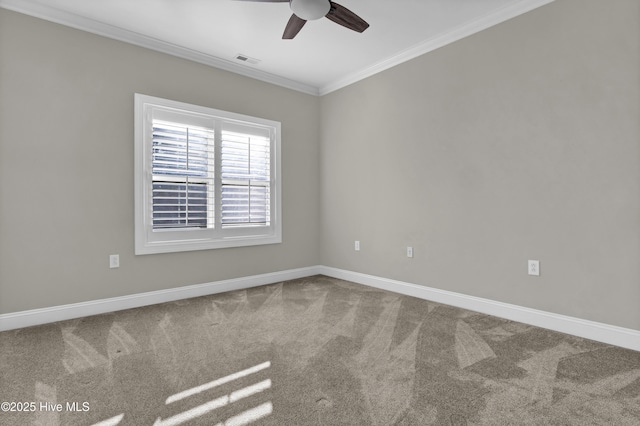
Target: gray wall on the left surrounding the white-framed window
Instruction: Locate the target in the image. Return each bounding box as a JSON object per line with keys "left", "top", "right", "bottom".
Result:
{"left": 0, "top": 9, "right": 320, "bottom": 313}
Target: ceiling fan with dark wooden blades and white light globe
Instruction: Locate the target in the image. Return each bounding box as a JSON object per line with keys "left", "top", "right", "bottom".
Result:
{"left": 239, "top": 0, "right": 369, "bottom": 40}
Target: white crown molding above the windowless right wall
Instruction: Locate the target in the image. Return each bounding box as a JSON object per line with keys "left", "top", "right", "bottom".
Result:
{"left": 318, "top": 0, "right": 555, "bottom": 96}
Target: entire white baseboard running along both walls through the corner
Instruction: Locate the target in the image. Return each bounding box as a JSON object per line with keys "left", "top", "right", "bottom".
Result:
{"left": 0, "top": 266, "right": 640, "bottom": 351}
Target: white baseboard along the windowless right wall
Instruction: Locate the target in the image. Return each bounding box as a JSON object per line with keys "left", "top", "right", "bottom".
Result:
{"left": 320, "top": 266, "right": 640, "bottom": 351}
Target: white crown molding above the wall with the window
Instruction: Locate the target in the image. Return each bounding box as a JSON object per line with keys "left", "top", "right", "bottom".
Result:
{"left": 0, "top": 0, "right": 319, "bottom": 96}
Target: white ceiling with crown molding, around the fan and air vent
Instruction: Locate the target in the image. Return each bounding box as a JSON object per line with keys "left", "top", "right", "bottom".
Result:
{"left": 0, "top": 0, "right": 553, "bottom": 95}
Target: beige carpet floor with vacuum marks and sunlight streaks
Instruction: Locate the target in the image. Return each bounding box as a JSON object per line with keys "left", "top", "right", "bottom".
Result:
{"left": 0, "top": 276, "right": 640, "bottom": 426}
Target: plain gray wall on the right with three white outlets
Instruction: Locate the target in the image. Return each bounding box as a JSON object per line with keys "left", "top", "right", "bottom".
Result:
{"left": 320, "top": 0, "right": 640, "bottom": 330}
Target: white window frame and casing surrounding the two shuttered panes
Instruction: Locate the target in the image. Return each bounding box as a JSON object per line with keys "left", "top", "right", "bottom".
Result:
{"left": 134, "top": 93, "right": 282, "bottom": 255}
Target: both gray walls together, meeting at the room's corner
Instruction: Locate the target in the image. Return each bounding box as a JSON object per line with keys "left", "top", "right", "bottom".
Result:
{"left": 0, "top": 0, "right": 640, "bottom": 329}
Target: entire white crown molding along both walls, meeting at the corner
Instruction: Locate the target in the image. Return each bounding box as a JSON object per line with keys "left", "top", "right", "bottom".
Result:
{"left": 0, "top": 0, "right": 555, "bottom": 96}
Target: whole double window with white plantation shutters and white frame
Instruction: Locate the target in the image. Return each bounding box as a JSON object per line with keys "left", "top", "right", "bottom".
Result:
{"left": 135, "top": 94, "right": 282, "bottom": 254}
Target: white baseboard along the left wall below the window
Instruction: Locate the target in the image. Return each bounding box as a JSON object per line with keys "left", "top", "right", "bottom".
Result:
{"left": 0, "top": 266, "right": 320, "bottom": 331}
